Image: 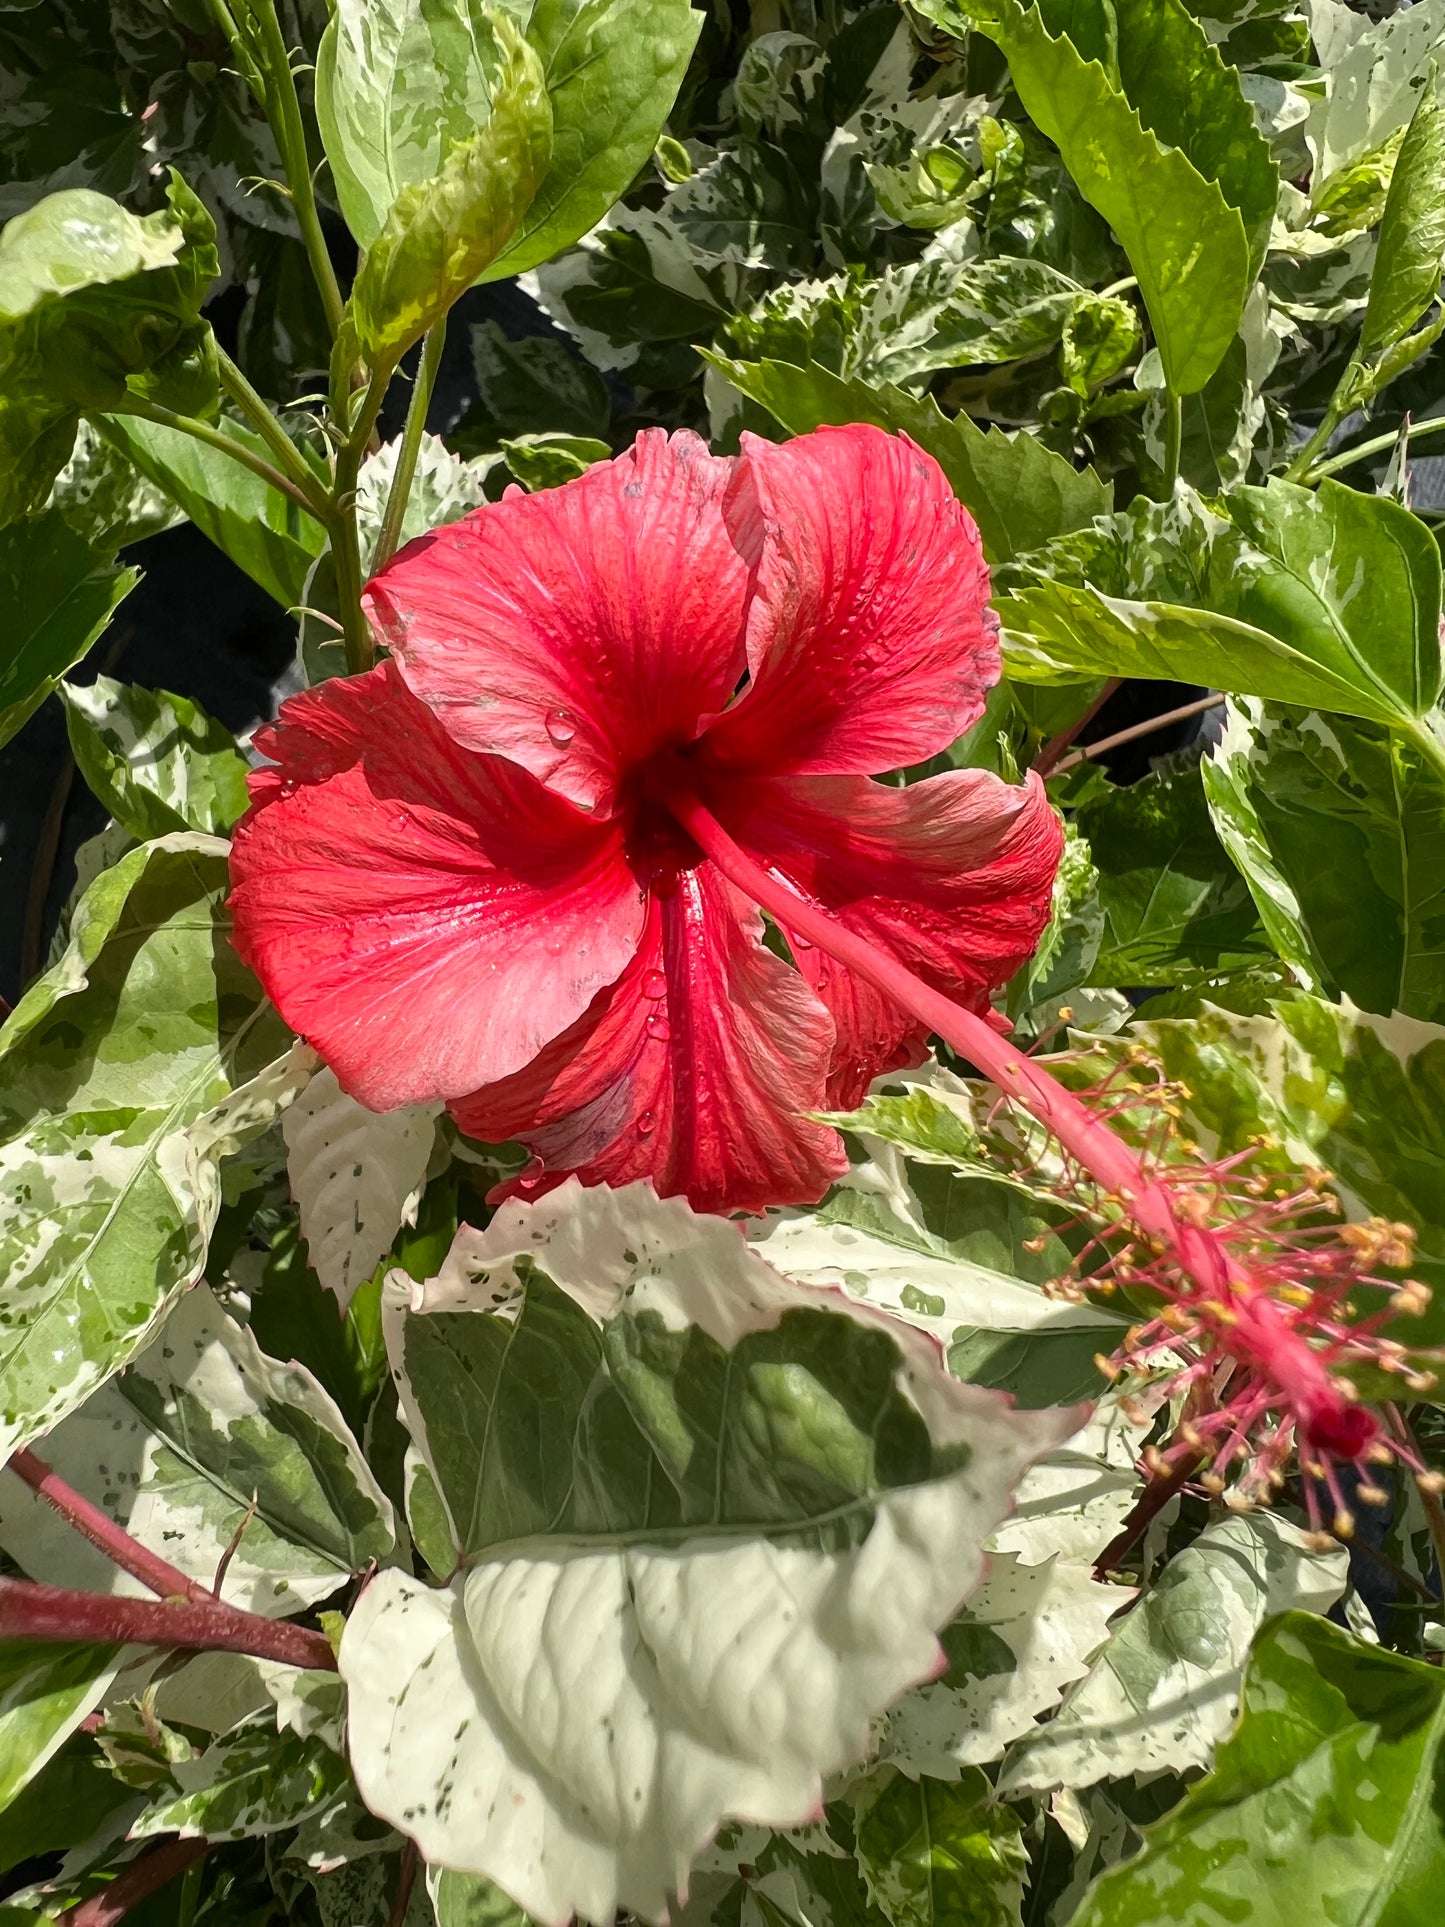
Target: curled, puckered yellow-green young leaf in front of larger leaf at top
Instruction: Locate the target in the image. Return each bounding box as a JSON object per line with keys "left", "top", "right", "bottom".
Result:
{"left": 347, "top": 13, "right": 553, "bottom": 370}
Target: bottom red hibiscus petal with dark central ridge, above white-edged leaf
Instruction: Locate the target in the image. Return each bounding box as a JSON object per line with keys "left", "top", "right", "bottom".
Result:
{"left": 451, "top": 863, "right": 848, "bottom": 1212}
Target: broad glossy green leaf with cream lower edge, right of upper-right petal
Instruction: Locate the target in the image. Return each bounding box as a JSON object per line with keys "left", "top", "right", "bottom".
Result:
{"left": 998, "top": 482, "right": 1441, "bottom": 736}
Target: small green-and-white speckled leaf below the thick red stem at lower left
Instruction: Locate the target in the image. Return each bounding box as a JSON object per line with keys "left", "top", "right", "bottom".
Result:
{"left": 131, "top": 1721, "right": 351, "bottom": 1840}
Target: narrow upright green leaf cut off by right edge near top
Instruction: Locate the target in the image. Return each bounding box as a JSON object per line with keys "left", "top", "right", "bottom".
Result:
{"left": 1358, "top": 67, "right": 1445, "bottom": 362}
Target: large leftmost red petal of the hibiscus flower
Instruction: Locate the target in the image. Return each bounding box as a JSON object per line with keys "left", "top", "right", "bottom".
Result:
{"left": 231, "top": 663, "right": 644, "bottom": 1110}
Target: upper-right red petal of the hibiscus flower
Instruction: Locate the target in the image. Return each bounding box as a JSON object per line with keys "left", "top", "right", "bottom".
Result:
{"left": 705, "top": 424, "right": 998, "bottom": 775}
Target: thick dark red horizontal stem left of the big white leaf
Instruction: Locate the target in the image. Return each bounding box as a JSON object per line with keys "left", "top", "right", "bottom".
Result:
{"left": 0, "top": 1578, "right": 335, "bottom": 1673}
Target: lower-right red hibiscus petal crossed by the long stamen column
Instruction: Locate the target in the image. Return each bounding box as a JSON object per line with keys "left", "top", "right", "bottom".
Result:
{"left": 709, "top": 769, "right": 1064, "bottom": 1110}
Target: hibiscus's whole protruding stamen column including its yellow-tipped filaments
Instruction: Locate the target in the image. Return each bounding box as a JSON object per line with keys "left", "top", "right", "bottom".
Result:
{"left": 659, "top": 759, "right": 1428, "bottom": 1495}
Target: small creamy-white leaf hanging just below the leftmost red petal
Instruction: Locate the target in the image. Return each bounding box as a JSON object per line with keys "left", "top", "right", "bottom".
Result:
{"left": 281, "top": 1069, "right": 441, "bottom": 1310}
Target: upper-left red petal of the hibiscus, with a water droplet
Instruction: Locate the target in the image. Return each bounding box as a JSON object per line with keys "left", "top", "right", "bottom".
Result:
{"left": 366, "top": 428, "right": 748, "bottom": 811}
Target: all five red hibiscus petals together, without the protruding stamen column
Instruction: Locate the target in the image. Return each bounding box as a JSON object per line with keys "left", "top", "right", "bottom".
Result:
{"left": 233, "top": 428, "right": 1060, "bottom": 1212}
